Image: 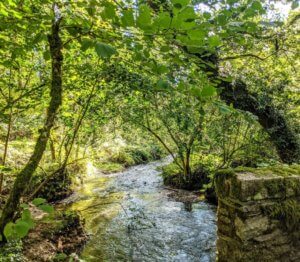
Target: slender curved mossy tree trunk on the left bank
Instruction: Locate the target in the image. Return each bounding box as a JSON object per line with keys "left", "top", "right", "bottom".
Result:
{"left": 0, "top": 19, "right": 63, "bottom": 237}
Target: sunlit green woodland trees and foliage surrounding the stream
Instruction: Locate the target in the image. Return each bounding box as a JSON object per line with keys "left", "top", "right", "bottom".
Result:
{"left": 0, "top": 0, "right": 300, "bottom": 258}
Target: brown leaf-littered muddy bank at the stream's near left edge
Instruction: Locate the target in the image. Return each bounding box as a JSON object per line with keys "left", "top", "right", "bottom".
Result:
{"left": 22, "top": 211, "right": 88, "bottom": 262}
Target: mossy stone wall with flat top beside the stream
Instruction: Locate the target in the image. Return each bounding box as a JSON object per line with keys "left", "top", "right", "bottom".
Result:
{"left": 216, "top": 170, "right": 300, "bottom": 262}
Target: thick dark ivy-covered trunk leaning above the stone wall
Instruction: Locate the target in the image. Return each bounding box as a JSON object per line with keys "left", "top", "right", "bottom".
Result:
{"left": 220, "top": 81, "right": 300, "bottom": 164}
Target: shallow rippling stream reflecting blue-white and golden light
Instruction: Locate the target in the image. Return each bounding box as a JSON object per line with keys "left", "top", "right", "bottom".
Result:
{"left": 71, "top": 159, "right": 216, "bottom": 262}
